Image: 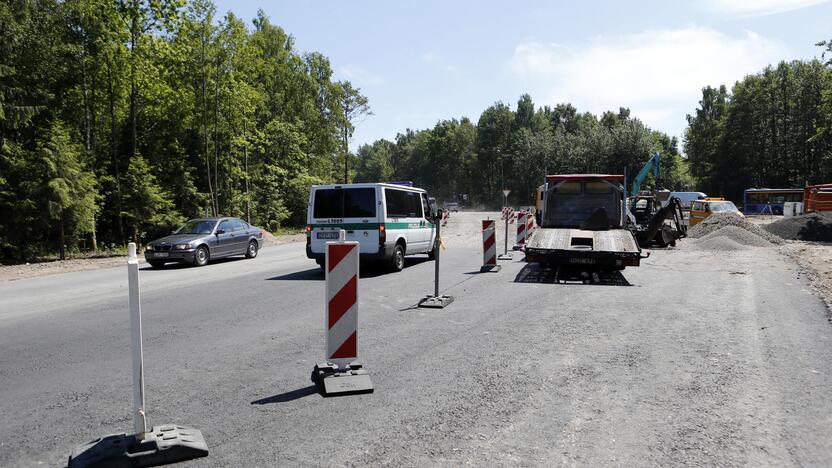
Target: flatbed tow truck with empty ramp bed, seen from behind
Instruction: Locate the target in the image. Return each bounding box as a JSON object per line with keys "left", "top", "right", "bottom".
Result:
{"left": 525, "top": 174, "right": 649, "bottom": 271}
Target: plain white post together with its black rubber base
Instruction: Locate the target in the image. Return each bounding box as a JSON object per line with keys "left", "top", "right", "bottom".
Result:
{"left": 68, "top": 242, "right": 208, "bottom": 468}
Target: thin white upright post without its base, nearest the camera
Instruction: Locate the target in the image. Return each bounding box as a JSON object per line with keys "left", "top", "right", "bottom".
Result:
{"left": 127, "top": 242, "right": 147, "bottom": 440}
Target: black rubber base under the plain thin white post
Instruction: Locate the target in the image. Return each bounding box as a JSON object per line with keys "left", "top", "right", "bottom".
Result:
{"left": 67, "top": 424, "right": 208, "bottom": 468}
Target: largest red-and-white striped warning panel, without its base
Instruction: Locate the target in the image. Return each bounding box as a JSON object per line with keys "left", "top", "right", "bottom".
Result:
{"left": 326, "top": 242, "right": 359, "bottom": 366}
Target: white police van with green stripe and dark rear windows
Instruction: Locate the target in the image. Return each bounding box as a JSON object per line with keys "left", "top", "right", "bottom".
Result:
{"left": 306, "top": 182, "right": 436, "bottom": 271}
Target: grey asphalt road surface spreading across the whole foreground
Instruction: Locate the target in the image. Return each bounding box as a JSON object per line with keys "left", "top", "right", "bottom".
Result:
{"left": 0, "top": 215, "right": 832, "bottom": 467}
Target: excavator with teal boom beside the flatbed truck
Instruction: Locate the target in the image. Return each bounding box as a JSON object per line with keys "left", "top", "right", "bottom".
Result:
{"left": 627, "top": 152, "right": 687, "bottom": 248}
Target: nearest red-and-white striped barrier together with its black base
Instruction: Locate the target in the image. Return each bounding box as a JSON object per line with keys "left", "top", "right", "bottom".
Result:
{"left": 312, "top": 229, "right": 373, "bottom": 397}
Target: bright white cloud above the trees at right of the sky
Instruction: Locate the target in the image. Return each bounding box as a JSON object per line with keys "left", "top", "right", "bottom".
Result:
{"left": 508, "top": 26, "right": 785, "bottom": 135}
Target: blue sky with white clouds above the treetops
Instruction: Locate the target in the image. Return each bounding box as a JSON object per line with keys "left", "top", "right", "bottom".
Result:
{"left": 215, "top": 0, "right": 832, "bottom": 148}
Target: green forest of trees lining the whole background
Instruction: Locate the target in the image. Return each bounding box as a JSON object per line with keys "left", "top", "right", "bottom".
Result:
{"left": 0, "top": 0, "right": 832, "bottom": 261}
